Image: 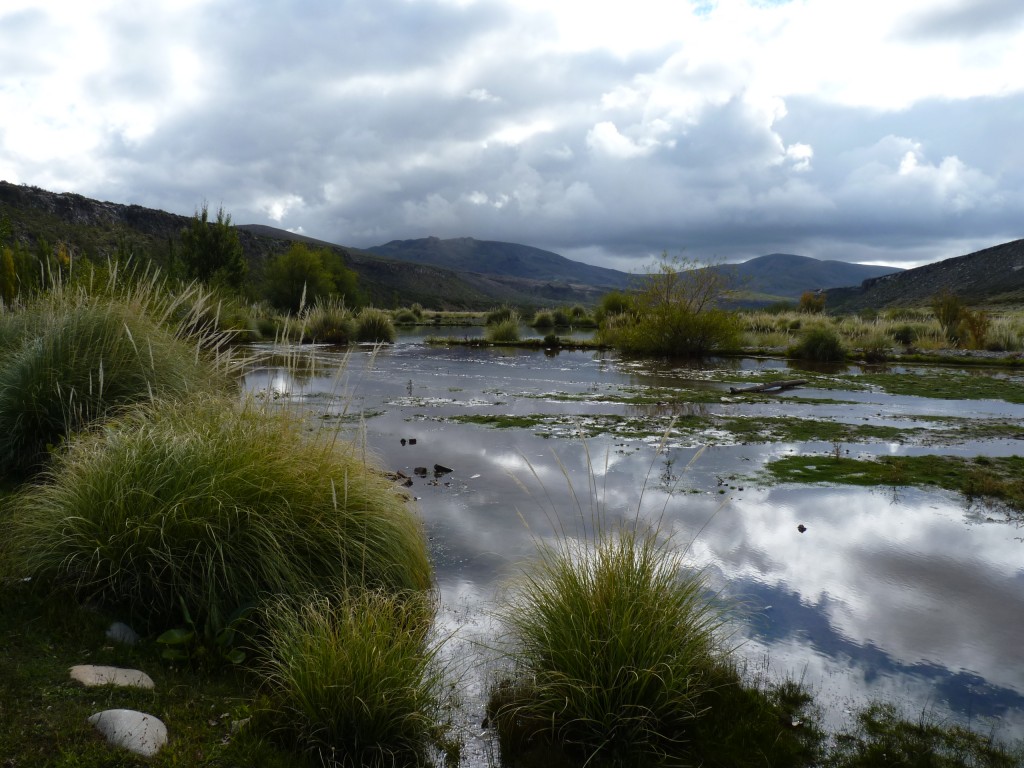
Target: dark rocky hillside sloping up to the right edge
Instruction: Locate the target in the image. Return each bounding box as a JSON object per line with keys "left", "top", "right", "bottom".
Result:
{"left": 827, "top": 240, "right": 1024, "bottom": 311}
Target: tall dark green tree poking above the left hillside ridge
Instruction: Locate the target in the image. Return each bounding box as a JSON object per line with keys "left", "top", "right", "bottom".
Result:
{"left": 181, "top": 202, "right": 247, "bottom": 290}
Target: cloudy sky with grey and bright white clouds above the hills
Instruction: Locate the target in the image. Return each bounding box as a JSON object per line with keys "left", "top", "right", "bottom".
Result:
{"left": 0, "top": 0, "right": 1024, "bottom": 269}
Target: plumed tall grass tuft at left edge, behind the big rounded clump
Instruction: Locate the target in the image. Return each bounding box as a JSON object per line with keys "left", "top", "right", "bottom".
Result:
{"left": 0, "top": 283, "right": 229, "bottom": 476}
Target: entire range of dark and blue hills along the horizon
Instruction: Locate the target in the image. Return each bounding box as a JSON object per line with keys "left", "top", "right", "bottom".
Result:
{"left": 0, "top": 181, "right": 1024, "bottom": 310}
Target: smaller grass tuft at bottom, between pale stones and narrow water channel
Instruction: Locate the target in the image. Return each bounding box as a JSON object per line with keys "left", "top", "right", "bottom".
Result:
{"left": 258, "top": 590, "right": 446, "bottom": 768}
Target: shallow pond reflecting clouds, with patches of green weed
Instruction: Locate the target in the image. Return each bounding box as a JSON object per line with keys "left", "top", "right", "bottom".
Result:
{"left": 241, "top": 342, "right": 1024, "bottom": 766}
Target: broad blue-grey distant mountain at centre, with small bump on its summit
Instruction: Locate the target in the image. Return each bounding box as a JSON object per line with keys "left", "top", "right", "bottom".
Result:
{"left": 367, "top": 238, "right": 635, "bottom": 290}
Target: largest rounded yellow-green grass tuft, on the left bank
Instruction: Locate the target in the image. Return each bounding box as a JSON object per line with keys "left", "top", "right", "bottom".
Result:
{"left": 7, "top": 397, "right": 431, "bottom": 632}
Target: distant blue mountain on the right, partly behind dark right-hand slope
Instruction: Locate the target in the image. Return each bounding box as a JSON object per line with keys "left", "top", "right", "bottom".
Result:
{"left": 724, "top": 253, "right": 900, "bottom": 304}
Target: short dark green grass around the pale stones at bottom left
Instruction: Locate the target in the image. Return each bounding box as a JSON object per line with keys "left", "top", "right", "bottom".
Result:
{"left": 0, "top": 582, "right": 308, "bottom": 768}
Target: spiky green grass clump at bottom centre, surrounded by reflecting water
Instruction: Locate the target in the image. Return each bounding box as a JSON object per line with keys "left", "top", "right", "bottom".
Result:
{"left": 488, "top": 528, "right": 815, "bottom": 765}
